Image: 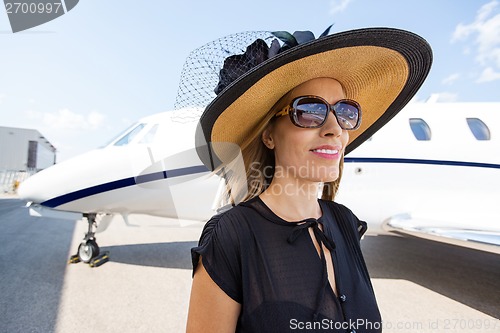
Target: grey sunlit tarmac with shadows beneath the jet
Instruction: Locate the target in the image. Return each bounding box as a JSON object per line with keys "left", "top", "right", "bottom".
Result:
{"left": 0, "top": 195, "right": 500, "bottom": 333}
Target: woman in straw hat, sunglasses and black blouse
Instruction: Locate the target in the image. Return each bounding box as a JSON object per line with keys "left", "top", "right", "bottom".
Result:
{"left": 187, "top": 28, "right": 432, "bottom": 332}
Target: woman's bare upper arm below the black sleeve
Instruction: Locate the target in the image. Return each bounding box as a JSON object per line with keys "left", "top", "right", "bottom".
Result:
{"left": 186, "top": 257, "right": 241, "bottom": 333}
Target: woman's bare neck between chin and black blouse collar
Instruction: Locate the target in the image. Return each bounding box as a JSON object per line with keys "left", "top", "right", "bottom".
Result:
{"left": 260, "top": 178, "right": 322, "bottom": 222}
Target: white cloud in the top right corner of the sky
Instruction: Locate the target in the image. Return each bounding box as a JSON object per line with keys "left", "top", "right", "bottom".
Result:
{"left": 451, "top": 0, "right": 500, "bottom": 82}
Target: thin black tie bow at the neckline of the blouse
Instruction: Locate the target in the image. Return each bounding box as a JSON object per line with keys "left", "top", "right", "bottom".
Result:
{"left": 287, "top": 220, "right": 335, "bottom": 321}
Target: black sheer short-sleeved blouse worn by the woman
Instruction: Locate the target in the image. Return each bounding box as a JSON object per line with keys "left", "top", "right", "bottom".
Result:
{"left": 191, "top": 197, "right": 382, "bottom": 333}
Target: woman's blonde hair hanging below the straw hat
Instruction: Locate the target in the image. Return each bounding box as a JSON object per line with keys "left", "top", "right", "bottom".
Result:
{"left": 219, "top": 89, "right": 344, "bottom": 206}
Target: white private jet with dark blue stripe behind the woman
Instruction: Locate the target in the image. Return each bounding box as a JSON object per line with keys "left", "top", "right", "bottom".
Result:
{"left": 18, "top": 102, "right": 500, "bottom": 263}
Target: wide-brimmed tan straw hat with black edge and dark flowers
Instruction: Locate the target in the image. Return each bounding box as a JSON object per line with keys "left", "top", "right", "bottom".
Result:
{"left": 188, "top": 28, "right": 432, "bottom": 170}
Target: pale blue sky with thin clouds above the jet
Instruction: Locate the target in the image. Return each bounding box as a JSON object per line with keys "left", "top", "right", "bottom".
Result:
{"left": 0, "top": 0, "right": 500, "bottom": 162}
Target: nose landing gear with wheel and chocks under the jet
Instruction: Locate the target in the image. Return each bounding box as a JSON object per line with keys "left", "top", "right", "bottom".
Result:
{"left": 69, "top": 213, "right": 109, "bottom": 267}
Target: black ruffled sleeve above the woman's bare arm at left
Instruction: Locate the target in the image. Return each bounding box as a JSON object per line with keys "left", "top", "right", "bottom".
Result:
{"left": 191, "top": 214, "right": 242, "bottom": 303}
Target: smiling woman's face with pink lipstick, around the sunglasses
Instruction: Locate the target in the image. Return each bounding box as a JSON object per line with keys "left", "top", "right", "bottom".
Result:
{"left": 262, "top": 78, "right": 349, "bottom": 182}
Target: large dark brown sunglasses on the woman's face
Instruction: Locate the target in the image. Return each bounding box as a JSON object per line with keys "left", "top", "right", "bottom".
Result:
{"left": 275, "top": 96, "right": 361, "bottom": 131}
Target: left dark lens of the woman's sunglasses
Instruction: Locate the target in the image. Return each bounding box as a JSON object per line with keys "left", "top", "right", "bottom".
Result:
{"left": 294, "top": 98, "right": 329, "bottom": 127}
